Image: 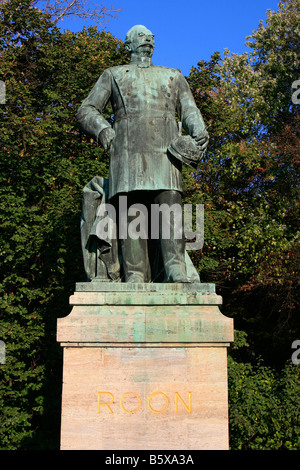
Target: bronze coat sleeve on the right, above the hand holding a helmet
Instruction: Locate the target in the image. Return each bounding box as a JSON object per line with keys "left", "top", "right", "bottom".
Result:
{"left": 176, "top": 73, "right": 206, "bottom": 139}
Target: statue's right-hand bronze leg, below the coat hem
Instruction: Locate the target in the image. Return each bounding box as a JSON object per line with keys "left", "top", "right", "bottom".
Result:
{"left": 154, "top": 191, "right": 189, "bottom": 282}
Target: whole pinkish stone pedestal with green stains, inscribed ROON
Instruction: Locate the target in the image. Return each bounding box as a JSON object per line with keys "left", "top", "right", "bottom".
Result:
{"left": 57, "top": 281, "right": 233, "bottom": 450}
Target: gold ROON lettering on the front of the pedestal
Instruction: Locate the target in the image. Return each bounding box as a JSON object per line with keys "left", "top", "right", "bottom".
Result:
{"left": 97, "top": 392, "right": 192, "bottom": 414}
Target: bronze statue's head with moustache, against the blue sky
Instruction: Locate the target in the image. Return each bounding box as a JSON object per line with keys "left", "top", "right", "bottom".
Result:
{"left": 125, "top": 24, "right": 154, "bottom": 57}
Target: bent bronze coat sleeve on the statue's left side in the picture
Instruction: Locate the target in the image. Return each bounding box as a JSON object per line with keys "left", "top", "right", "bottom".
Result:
{"left": 76, "top": 70, "right": 111, "bottom": 141}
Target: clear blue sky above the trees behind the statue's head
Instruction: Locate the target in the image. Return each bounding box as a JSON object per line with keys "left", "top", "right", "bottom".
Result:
{"left": 58, "top": 0, "right": 278, "bottom": 75}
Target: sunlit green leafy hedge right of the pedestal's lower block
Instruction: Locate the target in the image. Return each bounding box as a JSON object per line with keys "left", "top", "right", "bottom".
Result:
{"left": 228, "top": 335, "right": 300, "bottom": 450}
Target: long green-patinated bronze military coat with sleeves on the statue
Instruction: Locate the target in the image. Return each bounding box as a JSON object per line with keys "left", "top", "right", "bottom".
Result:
{"left": 77, "top": 64, "right": 205, "bottom": 198}
